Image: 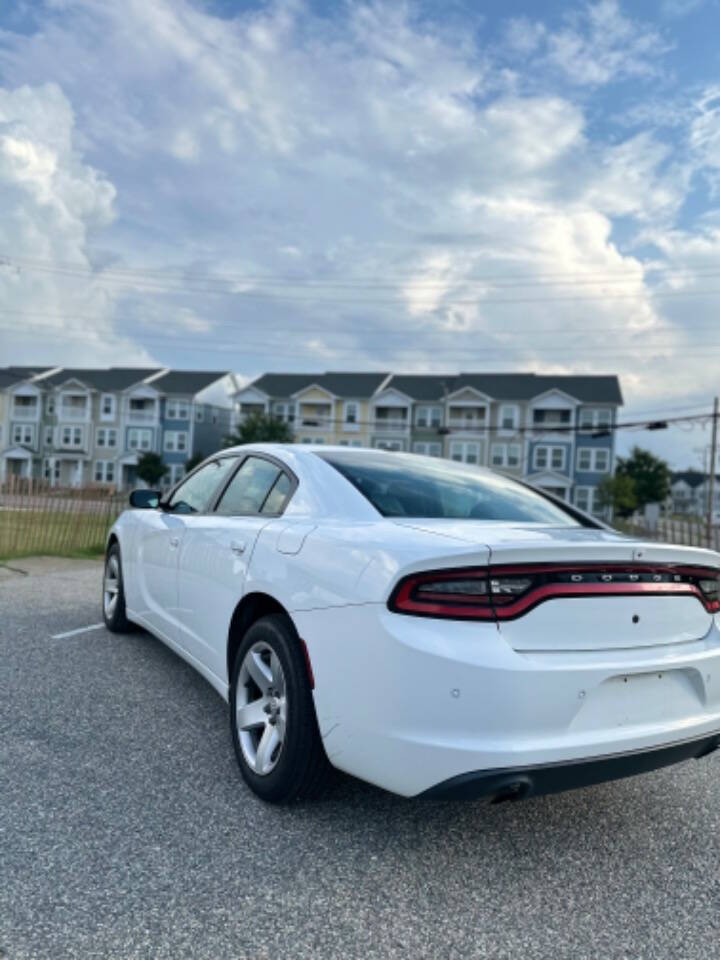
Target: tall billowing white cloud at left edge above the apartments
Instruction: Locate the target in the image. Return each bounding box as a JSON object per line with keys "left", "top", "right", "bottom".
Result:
{"left": 0, "top": 83, "right": 148, "bottom": 364}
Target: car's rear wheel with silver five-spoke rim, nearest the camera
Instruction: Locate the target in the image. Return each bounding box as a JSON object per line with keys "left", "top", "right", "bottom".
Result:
{"left": 230, "top": 614, "right": 331, "bottom": 803}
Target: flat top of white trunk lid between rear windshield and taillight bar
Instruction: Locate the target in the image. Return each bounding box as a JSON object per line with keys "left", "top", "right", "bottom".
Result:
{"left": 393, "top": 518, "right": 720, "bottom": 568}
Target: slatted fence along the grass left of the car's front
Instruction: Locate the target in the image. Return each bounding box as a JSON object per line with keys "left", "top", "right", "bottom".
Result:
{"left": 0, "top": 477, "right": 127, "bottom": 559}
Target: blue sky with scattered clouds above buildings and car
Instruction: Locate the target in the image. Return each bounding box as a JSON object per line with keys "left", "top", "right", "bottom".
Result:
{"left": 0, "top": 0, "right": 720, "bottom": 466}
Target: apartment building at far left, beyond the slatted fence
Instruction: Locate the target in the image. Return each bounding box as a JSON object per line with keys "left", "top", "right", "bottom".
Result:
{"left": 0, "top": 367, "right": 235, "bottom": 489}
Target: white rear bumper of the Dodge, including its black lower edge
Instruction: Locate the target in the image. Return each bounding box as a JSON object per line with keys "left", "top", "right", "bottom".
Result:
{"left": 294, "top": 598, "right": 720, "bottom": 797}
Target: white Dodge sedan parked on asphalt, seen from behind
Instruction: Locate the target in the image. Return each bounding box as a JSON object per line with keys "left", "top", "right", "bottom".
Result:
{"left": 103, "top": 444, "right": 720, "bottom": 802}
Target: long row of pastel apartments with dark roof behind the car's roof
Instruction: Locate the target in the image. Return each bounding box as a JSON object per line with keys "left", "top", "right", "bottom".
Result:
{"left": 235, "top": 373, "right": 623, "bottom": 514}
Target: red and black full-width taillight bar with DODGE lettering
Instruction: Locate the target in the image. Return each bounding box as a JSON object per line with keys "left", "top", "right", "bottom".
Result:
{"left": 388, "top": 564, "right": 720, "bottom": 620}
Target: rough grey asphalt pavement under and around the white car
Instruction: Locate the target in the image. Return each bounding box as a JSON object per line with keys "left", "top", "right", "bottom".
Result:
{"left": 0, "top": 561, "right": 720, "bottom": 960}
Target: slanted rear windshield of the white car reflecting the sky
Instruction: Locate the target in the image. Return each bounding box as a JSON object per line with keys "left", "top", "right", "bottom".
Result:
{"left": 317, "top": 451, "right": 579, "bottom": 527}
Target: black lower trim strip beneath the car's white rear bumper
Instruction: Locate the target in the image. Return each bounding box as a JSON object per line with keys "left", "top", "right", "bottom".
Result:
{"left": 420, "top": 733, "right": 720, "bottom": 803}
